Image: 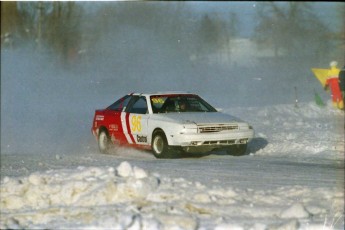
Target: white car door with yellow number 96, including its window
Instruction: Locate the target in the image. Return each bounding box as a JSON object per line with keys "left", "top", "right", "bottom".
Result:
{"left": 121, "top": 96, "right": 149, "bottom": 145}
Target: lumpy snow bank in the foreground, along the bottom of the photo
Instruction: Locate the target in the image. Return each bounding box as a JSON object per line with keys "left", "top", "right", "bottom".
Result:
{"left": 0, "top": 161, "right": 344, "bottom": 230}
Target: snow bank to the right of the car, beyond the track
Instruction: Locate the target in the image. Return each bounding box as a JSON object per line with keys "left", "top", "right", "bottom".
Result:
{"left": 225, "top": 101, "right": 344, "bottom": 156}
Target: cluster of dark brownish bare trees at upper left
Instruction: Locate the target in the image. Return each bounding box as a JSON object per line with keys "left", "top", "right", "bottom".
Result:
{"left": 1, "top": 2, "right": 82, "bottom": 62}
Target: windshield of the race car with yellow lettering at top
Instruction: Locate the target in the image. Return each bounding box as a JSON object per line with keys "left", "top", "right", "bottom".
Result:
{"left": 150, "top": 94, "right": 217, "bottom": 113}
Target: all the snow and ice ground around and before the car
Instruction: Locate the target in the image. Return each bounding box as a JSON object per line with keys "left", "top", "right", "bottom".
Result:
{"left": 0, "top": 103, "right": 344, "bottom": 230}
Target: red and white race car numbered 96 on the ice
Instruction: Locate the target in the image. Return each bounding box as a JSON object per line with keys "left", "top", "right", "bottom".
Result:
{"left": 92, "top": 92, "right": 254, "bottom": 158}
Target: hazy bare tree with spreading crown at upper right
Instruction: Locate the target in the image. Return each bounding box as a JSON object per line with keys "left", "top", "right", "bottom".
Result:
{"left": 254, "top": 2, "right": 330, "bottom": 63}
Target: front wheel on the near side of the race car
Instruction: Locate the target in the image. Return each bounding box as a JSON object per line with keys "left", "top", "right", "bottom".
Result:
{"left": 151, "top": 130, "right": 171, "bottom": 158}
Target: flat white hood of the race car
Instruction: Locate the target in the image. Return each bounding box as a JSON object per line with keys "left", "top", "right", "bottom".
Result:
{"left": 155, "top": 112, "right": 243, "bottom": 124}
